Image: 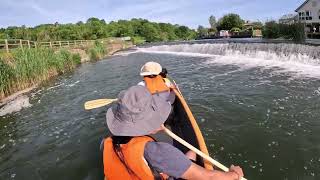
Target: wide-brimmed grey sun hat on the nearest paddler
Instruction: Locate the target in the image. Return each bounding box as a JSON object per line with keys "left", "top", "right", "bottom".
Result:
{"left": 106, "top": 86, "right": 171, "bottom": 136}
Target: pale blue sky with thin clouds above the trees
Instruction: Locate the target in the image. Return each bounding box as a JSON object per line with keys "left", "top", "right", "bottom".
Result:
{"left": 0, "top": 0, "right": 304, "bottom": 28}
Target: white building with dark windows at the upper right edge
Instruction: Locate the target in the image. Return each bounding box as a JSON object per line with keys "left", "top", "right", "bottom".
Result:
{"left": 296, "top": 0, "right": 320, "bottom": 38}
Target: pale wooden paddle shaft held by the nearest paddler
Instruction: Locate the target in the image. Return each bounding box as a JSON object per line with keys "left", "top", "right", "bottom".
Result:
{"left": 163, "top": 127, "right": 246, "bottom": 180}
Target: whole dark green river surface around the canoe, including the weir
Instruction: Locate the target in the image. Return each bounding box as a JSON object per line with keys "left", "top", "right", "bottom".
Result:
{"left": 0, "top": 43, "right": 320, "bottom": 180}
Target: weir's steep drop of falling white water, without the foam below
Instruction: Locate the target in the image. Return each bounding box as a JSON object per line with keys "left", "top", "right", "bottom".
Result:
{"left": 143, "top": 43, "right": 320, "bottom": 64}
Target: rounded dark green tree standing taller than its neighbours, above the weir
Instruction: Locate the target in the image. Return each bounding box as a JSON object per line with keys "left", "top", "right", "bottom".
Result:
{"left": 217, "top": 13, "right": 244, "bottom": 30}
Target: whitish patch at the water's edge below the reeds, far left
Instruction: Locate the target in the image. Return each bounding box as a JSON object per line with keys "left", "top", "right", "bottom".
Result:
{"left": 0, "top": 95, "right": 31, "bottom": 116}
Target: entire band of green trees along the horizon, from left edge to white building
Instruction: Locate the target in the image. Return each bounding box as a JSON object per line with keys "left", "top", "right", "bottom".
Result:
{"left": 0, "top": 13, "right": 305, "bottom": 44}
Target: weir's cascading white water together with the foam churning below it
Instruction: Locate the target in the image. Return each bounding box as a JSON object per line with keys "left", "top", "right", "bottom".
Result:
{"left": 138, "top": 43, "right": 320, "bottom": 78}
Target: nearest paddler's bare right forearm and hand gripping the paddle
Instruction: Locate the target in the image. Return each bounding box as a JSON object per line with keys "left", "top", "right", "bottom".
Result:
{"left": 182, "top": 163, "right": 243, "bottom": 180}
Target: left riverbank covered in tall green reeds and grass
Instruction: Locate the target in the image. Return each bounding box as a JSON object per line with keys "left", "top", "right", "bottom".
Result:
{"left": 0, "top": 41, "right": 126, "bottom": 100}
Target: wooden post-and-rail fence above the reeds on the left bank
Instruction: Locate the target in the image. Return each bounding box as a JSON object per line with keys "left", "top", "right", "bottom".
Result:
{"left": 0, "top": 39, "right": 110, "bottom": 52}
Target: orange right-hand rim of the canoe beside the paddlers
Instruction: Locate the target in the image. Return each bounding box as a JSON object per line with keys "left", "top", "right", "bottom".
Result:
{"left": 173, "top": 88, "right": 213, "bottom": 170}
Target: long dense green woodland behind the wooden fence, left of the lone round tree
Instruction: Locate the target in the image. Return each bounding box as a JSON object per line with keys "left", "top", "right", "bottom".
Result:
{"left": 0, "top": 18, "right": 197, "bottom": 42}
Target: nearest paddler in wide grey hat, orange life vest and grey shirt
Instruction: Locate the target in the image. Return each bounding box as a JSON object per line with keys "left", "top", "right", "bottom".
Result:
{"left": 103, "top": 86, "right": 243, "bottom": 180}
